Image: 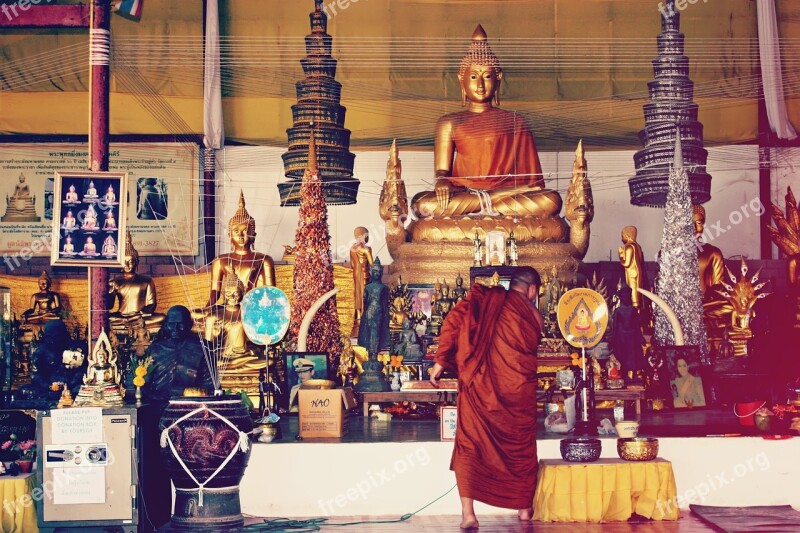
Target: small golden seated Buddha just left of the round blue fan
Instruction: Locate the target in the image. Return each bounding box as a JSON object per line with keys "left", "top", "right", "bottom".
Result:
{"left": 205, "top": 276, "right": 260, "bottom": 371}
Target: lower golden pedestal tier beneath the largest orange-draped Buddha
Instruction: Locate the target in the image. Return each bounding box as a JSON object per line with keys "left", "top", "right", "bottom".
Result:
{"left": 384, "top": 239, "right": 581, "bottom": 284}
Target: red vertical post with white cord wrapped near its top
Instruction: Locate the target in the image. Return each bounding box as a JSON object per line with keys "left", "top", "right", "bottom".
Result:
{"left": 88, "top": 0, "right": 111, "bottom": 341}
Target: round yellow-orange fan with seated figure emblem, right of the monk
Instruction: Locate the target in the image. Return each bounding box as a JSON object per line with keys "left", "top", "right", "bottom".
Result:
{"left": 557, "top": 289, "right": 608, "bottom": 348}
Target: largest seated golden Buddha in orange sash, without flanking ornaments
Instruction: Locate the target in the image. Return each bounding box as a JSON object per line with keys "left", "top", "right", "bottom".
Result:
{"left": 411, "top": 25, "right": 568, "bottom": 242}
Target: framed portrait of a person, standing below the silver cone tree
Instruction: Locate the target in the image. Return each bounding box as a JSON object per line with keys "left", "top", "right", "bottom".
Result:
{"left": 654, "top": 346, "right": 706, "bottom": 409}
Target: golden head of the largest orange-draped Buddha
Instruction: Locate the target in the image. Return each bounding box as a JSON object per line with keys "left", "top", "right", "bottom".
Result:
{"left": 458, "top": 24, "right": 503, "bottom": 105}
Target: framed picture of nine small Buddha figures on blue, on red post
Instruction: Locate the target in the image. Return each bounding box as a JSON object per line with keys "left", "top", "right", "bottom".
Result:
{"left": 50, "top": 171, "right": 128, "bottom": 266}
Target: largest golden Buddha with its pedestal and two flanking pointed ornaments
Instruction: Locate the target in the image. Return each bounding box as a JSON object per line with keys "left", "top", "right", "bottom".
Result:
{"left": 380, "top": 26, "right": 594, "bottom": 283}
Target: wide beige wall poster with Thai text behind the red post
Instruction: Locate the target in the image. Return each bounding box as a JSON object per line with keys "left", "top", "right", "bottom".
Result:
{"left": 0, "top": 141, "right": 203, "bottom": 258}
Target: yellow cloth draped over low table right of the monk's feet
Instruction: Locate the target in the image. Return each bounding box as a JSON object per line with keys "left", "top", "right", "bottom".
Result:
{"left": 533, "top": 459, "right": 680, "bottom": 522}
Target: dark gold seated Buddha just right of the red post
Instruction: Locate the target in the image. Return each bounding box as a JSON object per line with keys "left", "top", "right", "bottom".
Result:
{"left": 107, "top": 232, "right": 164, "bottom": 332}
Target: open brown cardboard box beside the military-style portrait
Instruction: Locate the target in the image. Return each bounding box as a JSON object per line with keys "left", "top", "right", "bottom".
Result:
{"left": 297, "top": 387, "right": 356, "bottom": 439}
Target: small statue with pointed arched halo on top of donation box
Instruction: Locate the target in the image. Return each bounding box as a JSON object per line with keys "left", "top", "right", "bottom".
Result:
{"left": 73, "top": 331, "right": 125, "bottom": 407}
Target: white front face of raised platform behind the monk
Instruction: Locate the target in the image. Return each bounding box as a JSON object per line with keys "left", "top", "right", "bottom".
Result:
{"left": 241, "top": 432, "right": 800, "bottom": 517}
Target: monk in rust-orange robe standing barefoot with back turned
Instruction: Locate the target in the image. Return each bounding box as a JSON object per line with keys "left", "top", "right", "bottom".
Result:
{"left": 431, "top": 267, "right": 542, "bottom": 529}
